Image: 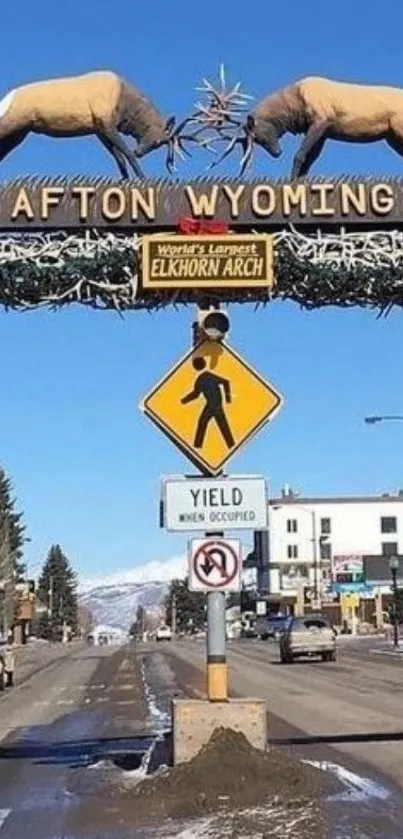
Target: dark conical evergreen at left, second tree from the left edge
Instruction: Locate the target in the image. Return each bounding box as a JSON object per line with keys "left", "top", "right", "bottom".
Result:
{"left": 37, "top": 545, "right": 77, "bottom": 641}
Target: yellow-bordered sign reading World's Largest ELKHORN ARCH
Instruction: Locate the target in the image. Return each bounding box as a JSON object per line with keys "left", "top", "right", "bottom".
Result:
{"left": 141, "top": 233, "right": 273, "bottom": 291}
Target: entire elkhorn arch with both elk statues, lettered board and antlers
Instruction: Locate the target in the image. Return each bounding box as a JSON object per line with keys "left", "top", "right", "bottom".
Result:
{"left": 0, "top": 65, "right": 403, "bottom": 312}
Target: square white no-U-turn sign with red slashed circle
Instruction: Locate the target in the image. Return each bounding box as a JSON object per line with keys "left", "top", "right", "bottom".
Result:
{"left": 189, "top": 538, "right": 242, "bottom": 592}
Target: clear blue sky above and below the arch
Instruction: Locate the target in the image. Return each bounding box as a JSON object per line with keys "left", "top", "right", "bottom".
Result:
{"left": 0, "top": 0, "right": 403, "bottom": 576}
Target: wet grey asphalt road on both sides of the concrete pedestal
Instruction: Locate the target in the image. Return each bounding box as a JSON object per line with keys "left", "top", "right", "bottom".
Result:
{"left": 0, "top": 641, "right": 403, "bottom": 839}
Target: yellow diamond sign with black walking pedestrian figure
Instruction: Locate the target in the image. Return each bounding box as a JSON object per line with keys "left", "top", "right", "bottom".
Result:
{"left": 140, "top": 341, "right": 283, "bottom": 475}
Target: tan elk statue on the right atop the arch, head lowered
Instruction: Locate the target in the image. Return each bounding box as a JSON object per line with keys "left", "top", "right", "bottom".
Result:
{"left": 210, "top": 76, "right": 403, "bottom": 179}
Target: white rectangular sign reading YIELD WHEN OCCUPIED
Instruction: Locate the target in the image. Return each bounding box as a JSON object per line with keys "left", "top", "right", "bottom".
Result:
{"left": 162, "top": 475, "right": 268, "bottom": 532}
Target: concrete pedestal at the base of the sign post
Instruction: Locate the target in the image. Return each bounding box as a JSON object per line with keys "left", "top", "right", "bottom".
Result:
{"left": 172, "top": 699, "right": 267, "bottom": 765}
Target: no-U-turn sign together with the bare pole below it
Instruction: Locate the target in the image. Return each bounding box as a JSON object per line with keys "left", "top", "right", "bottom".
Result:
{"left": 189, "top": 531, "right": 242, "bottom": 702}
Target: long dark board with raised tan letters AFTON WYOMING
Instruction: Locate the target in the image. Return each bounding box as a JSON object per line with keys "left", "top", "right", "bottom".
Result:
{"left": 0, "top": 178, "right": 403, "bottom": 232}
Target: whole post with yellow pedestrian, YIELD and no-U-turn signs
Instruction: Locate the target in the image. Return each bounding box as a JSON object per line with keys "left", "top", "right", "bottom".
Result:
{"left": 140, "top": 304, "right": 283, "bottom": 702}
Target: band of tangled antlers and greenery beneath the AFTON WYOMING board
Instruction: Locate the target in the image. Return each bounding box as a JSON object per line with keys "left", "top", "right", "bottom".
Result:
{"left": 0, "top": 233, "right": 403, "bottom": 311}
